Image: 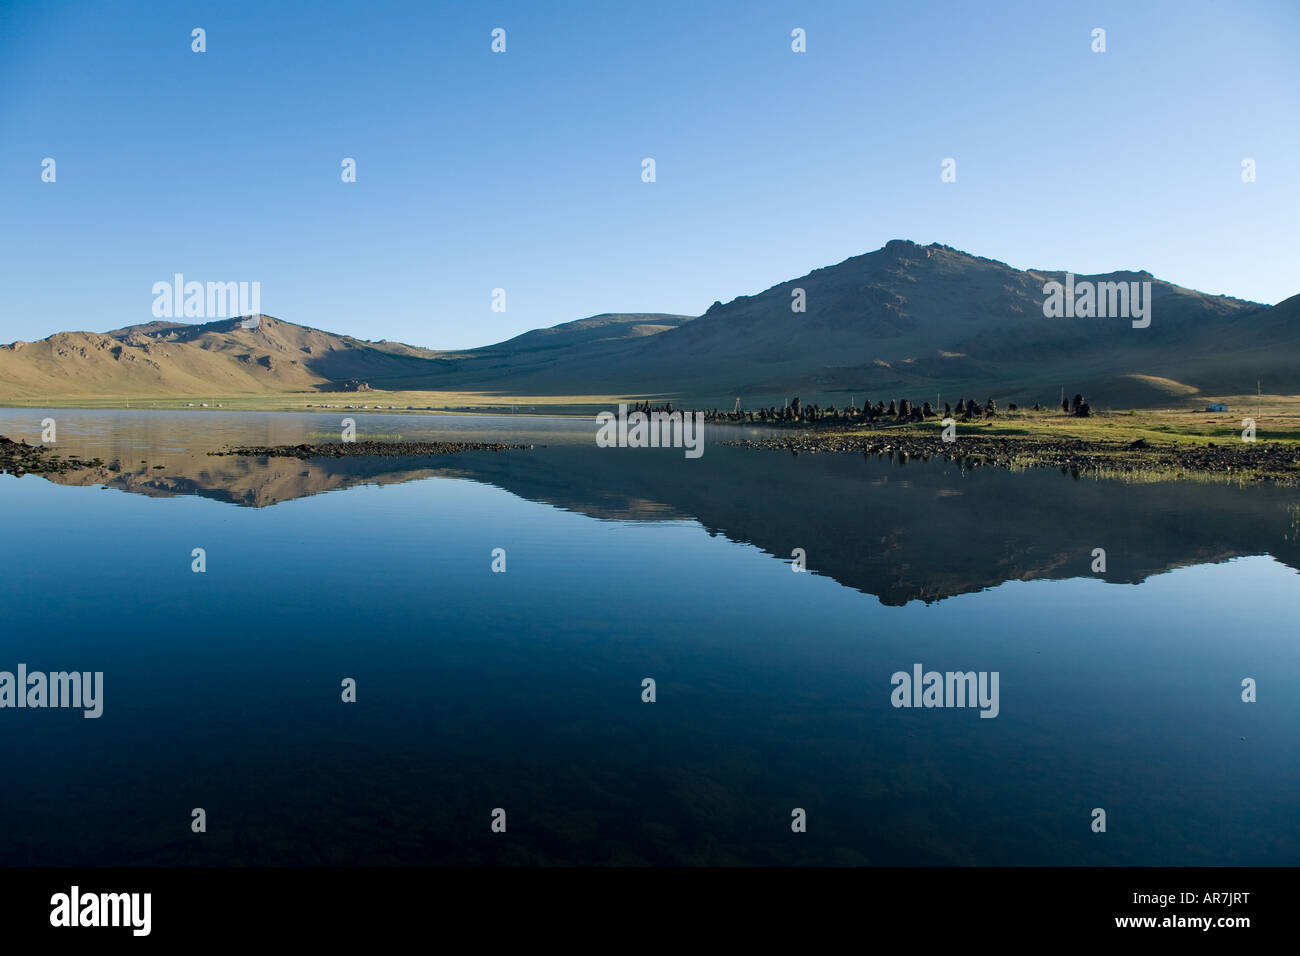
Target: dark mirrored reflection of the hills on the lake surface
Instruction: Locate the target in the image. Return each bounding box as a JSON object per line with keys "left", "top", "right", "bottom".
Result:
{"left": 10, "top": 412, "right": 1300, "bottom": 605}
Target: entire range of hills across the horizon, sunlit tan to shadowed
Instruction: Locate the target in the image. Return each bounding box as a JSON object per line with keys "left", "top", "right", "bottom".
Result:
{"left": 0, "top": 239, "right": 1300, "bottom": 408}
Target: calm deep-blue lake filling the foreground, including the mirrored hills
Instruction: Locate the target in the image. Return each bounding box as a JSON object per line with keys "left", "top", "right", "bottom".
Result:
{"left": 0, "top": 410, "right": 1300, "bottom": 865}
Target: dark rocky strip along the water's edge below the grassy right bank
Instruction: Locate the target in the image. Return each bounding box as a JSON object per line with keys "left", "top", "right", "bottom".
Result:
{"left": 723, "top": 433, "right": 1300, "bottom": 485}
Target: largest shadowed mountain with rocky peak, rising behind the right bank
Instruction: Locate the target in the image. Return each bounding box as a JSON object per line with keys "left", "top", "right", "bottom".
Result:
{"left": 418, "top": 241, "right": 1279, "bottom": 407}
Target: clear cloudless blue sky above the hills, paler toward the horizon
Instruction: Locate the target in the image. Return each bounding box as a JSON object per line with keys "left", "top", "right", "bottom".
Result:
{"left": 0, "top": 0, "right": 1300, "bottom": 347}
